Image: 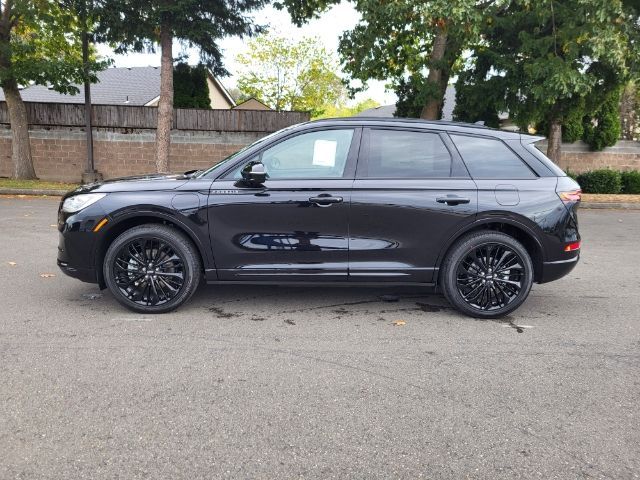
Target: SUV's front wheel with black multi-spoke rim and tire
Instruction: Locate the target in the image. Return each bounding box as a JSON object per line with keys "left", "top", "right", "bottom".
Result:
{"left": 103, "top": 224, "right": 202, "bottom": 313}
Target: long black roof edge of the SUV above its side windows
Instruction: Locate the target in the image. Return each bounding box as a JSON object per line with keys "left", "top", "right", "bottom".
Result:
{"left": 299, "top": 117, "right": 523, "bottom": 140}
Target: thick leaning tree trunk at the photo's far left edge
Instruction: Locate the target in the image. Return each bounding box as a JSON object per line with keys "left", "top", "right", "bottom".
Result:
{"left": 2, "top": 79, "right": 38, "bottom": 180}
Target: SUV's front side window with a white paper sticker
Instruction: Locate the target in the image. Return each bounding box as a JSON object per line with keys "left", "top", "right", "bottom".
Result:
{"left": 227, "top": 129, "right": 353, "bottom": 180}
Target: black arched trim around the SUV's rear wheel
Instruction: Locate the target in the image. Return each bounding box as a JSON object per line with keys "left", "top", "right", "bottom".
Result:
{"left": 435, "top": 216, "right": 544, "bottom": 284}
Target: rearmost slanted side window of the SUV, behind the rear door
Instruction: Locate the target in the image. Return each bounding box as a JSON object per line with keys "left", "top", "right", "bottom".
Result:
{"left": 450, "top": 135, "right": 536, "bottom": 179}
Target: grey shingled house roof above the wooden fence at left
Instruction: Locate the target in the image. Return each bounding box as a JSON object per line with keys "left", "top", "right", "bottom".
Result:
{"left": 0, "top": 67, "right": 235, "bottom": 107}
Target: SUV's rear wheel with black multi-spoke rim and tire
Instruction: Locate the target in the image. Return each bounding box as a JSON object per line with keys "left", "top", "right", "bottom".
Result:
{"left": 440, "top": 231, "right": 534, "bottom": 318}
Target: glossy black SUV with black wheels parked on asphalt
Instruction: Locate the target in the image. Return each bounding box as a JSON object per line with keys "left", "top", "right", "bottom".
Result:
{"left": 58, "top": 118, "right": 580, "bottom": 317}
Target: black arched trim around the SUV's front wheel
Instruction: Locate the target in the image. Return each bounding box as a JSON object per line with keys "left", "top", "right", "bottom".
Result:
{"left": 95, "top": 212, "right": 210, "bottom": 289}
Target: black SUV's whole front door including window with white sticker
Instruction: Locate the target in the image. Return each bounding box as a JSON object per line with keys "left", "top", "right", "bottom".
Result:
{"left": 208, "top": 128, "right": 360, "bottom": 282}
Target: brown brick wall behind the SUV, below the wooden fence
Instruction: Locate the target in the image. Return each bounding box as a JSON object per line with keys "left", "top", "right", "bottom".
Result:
{"left": 0, "top": 126, "right": 640, "bottom": 182}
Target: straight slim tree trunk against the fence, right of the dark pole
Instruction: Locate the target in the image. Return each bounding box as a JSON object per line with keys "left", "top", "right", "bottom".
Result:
{"left": 156, "top": 22, "right": 173, "bottom": 173}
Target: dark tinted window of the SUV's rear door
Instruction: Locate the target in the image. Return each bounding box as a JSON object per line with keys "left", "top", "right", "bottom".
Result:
{"left": 361, "top": 129, "right": 451, "bottom": 178}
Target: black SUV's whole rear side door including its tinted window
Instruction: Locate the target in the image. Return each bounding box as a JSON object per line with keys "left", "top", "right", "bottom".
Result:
{"left": 349, "top": 127, "right": 478, "bottom": 283}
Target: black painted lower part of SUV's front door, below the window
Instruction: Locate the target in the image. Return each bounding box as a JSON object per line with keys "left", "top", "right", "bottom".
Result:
{"left": 208, "top": 179, "right": 353, "bottom": 281}
